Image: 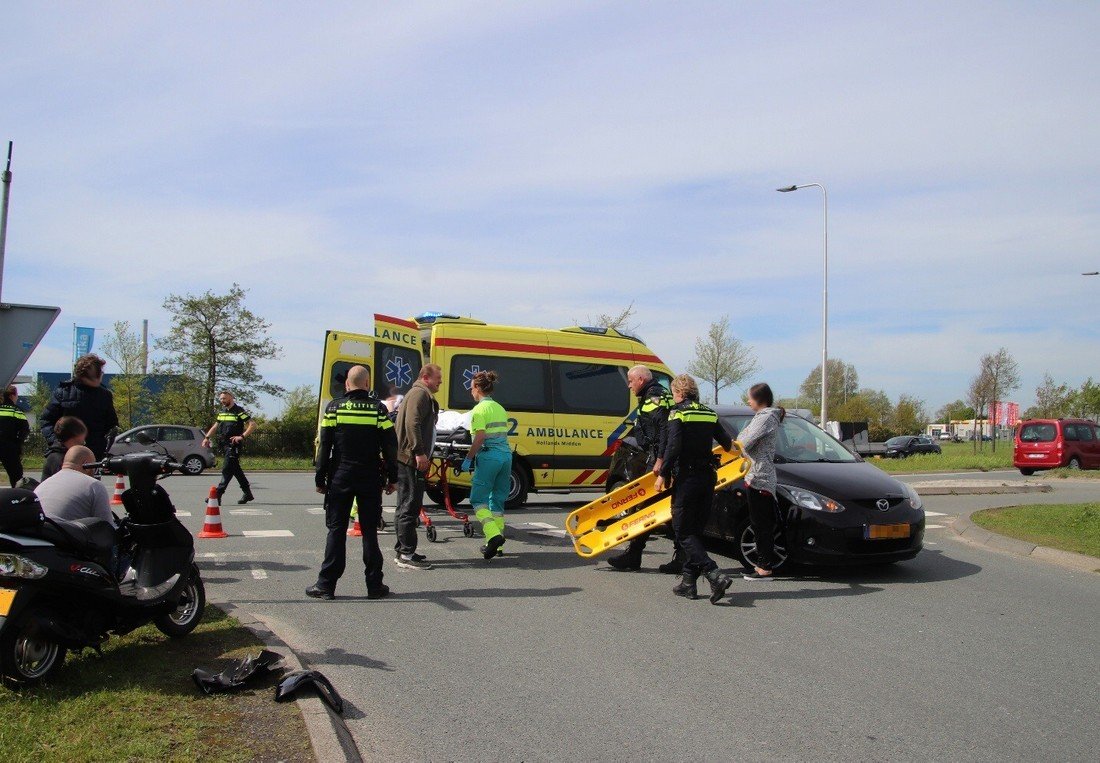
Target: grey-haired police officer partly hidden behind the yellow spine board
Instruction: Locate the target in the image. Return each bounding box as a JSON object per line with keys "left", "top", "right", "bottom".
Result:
{"left": 607, "top": 366, "right": 683, "bottom": 575}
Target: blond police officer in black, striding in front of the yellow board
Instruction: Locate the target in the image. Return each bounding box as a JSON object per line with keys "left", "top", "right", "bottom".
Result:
{"left": 655, "top": 374, "right": 733, "bottom": 604}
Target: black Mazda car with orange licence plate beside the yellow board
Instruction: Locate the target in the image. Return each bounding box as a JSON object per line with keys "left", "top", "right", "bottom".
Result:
{"left": 607, "top": 406, "right": 924, "bottom": 566}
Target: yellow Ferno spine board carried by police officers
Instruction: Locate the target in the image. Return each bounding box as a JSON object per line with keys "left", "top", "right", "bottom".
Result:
{"left": 565, "top": 442, "right": 749, "bottom": 557}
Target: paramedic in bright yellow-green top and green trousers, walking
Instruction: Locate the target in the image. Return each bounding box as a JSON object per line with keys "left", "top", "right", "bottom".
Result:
{"left": 462, "top": 371, "right": 512, "bottom": 560}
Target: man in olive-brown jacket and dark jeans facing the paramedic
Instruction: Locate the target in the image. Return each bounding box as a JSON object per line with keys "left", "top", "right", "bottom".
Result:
{"left": 394, "top": 363, "right": 443, "bottom": 570}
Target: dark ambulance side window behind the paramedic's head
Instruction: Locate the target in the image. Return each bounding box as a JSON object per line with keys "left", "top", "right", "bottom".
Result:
{"left": 447, "top": 355, "right": 552, "bottom": 413}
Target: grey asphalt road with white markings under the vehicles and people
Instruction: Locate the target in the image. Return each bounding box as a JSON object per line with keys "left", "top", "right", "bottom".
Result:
{"left": 166, "top": 474, "right": 1100, "bottom": 761}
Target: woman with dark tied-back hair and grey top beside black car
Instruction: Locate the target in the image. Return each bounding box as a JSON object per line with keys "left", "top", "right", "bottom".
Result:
{"left": 737, "top": 384, "right": 787, "bottom": 580}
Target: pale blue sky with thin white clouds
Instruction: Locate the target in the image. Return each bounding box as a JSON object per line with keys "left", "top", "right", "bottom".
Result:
{"left": 0, "top": 1, "right": 1100, "bottom": 413}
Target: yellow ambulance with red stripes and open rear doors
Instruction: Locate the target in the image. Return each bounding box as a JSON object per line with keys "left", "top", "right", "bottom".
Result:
{"left": 319, "top": 312, "right": 672, "bottom": 507}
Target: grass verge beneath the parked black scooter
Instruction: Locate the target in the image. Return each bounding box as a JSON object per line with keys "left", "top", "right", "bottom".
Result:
{"left": 0, "top": 606, "right": 314, "bottom": 763}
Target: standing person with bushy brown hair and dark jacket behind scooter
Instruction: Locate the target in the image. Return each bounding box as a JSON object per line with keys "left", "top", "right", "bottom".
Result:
{"left": 39, "top": 355, "right": 119, "bottom": 460}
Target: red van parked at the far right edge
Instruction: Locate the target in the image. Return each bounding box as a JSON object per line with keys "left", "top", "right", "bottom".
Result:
{"left": 1012, "top": 419, "right": 1100, "bottom": 475}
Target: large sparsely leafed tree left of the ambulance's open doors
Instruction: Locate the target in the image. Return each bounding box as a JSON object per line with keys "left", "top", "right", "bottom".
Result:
{"left": 156, "top": 284, "right": 284, "bottom": 425}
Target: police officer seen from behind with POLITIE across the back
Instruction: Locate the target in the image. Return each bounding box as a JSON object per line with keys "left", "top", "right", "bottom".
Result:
{"left": 306, "top": 366, "right": 397, "bottom": 599}
